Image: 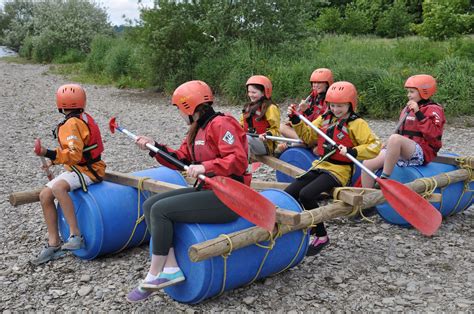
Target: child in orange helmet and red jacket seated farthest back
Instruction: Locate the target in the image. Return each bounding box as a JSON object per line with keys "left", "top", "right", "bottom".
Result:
{"left": 275, "top": 68, "right": 334, "bottom": 154}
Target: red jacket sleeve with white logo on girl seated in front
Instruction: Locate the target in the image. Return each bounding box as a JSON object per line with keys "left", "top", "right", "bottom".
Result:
{"left": 202, "top": 116, "right": 248, "bottom": 177}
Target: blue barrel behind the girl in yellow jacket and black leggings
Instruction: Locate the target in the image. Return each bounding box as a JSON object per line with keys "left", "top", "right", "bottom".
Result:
{"left": 276, "top": 147, "right": 360, "bottom": 185}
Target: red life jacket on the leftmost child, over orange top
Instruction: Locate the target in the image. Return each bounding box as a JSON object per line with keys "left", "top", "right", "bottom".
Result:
{"left": 53, "top": 112, "right": 104, "bottom": 181}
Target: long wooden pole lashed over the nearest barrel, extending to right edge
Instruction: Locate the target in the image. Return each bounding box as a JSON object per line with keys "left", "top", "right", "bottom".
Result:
{"left": 188, "top": 169, "right": 473, "bottom": 262}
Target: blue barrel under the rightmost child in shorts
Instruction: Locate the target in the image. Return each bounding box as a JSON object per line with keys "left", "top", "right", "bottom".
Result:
{"left": 377, "top": 158, "right": 474, "bottom": 226}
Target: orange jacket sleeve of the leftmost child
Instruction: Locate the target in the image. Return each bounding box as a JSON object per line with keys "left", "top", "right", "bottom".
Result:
{"left": 53, "top": 118, "right": 90, "bottom": 166}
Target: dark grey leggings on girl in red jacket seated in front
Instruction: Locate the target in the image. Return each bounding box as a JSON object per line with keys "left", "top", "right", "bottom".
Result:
{"left": 143, "top": 188, "right": 239, "bottom": 255}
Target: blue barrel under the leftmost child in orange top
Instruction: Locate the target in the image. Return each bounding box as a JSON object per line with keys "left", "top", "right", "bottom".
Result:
{"left": 58, "top": 167, "right": 187, "bottom": 260}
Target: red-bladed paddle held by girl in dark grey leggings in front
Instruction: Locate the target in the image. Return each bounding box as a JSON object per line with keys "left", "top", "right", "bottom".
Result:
{"left": 109, "top": 117, "right": 276, "bottom": 232}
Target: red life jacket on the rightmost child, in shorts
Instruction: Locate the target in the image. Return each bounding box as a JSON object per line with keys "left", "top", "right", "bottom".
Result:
{"left": 397, "top": 101, "right": 445, "bottom": 164}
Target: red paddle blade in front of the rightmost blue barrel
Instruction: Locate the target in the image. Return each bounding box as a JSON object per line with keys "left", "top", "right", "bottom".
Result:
{"left": 377, "top": 178, "right": 442, "bottom": 236}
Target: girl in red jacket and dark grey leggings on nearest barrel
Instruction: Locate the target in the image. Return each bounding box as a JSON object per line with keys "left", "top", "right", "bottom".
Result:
{"left": 127, "top": 81, "right": 251, "bottom": 302}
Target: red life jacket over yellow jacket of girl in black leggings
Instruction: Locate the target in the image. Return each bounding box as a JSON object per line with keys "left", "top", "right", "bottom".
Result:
{"left": 317, "top": 111, "right": 359, "bottom": 165}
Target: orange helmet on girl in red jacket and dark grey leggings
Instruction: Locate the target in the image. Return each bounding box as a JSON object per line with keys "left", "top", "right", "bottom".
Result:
{"left": 171, "top": 81, "right": 214, "bottom": 116}
